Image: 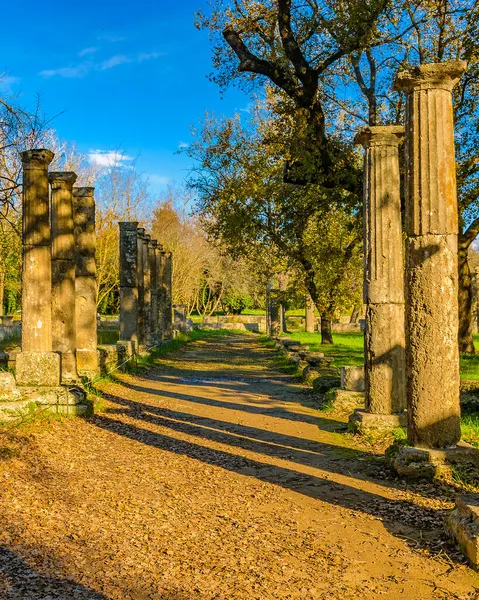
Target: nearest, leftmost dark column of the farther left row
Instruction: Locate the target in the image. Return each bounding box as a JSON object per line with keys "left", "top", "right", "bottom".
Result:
{"left": 120, "top": 222, "right": 138, "bottom": 350}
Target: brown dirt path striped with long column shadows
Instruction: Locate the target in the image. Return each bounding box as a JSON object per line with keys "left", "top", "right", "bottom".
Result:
{"left": 0, "top": 336, "right": 479, "bottom": 600}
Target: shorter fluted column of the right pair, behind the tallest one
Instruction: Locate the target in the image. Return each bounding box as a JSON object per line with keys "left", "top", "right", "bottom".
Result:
{"left": 356, "top": 126, "right": 406, "bottom": 426}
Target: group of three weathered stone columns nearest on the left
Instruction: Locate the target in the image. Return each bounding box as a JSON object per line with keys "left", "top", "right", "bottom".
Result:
{"left": 16, "top": 149, "right": 98, "bottom": 387}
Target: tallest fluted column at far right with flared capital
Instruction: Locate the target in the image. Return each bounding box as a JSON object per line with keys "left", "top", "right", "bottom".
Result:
{"left": 395, "top": 61, "right": 466, "bottom": 448}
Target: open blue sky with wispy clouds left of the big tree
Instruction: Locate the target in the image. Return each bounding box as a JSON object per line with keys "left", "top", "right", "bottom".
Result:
{"left": 0, "top": 0, "right": 248, "bottom": 192}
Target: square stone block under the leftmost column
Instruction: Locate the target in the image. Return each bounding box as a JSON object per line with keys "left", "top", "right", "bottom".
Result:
{"left": 16, "top": 352, "right": 60, "bottom": 387}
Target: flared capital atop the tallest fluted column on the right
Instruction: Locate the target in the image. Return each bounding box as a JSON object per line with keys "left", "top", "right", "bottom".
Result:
{"left": 394, "top": 60, "right": 467, "bottom": 94}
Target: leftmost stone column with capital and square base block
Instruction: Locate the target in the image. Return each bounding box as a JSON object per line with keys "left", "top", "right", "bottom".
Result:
{"left": 16, "top": 150, "right": 60, "bottom": 386}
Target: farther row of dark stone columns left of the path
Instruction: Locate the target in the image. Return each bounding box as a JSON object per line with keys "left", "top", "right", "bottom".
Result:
{"left": 120, "top": 221, "right": 173, "bottom": 352}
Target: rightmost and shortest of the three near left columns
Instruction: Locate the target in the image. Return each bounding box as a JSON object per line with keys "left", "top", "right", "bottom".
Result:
{"left": 73, "top": 187, "right": 98, "bottom": 378}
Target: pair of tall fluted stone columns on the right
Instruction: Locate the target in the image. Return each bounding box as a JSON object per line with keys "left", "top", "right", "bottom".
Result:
{"left": 354, "top": 61, "right": 466, "bottom": 448}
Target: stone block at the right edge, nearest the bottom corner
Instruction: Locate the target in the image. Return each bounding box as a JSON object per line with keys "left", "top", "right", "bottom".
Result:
{"left": 445, "top": 494, "right": 479, "bottom": 569}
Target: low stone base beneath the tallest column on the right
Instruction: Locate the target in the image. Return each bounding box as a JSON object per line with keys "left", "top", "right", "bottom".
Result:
{"left": 386, "top": 442, "right": 479, "bottom": 479}
